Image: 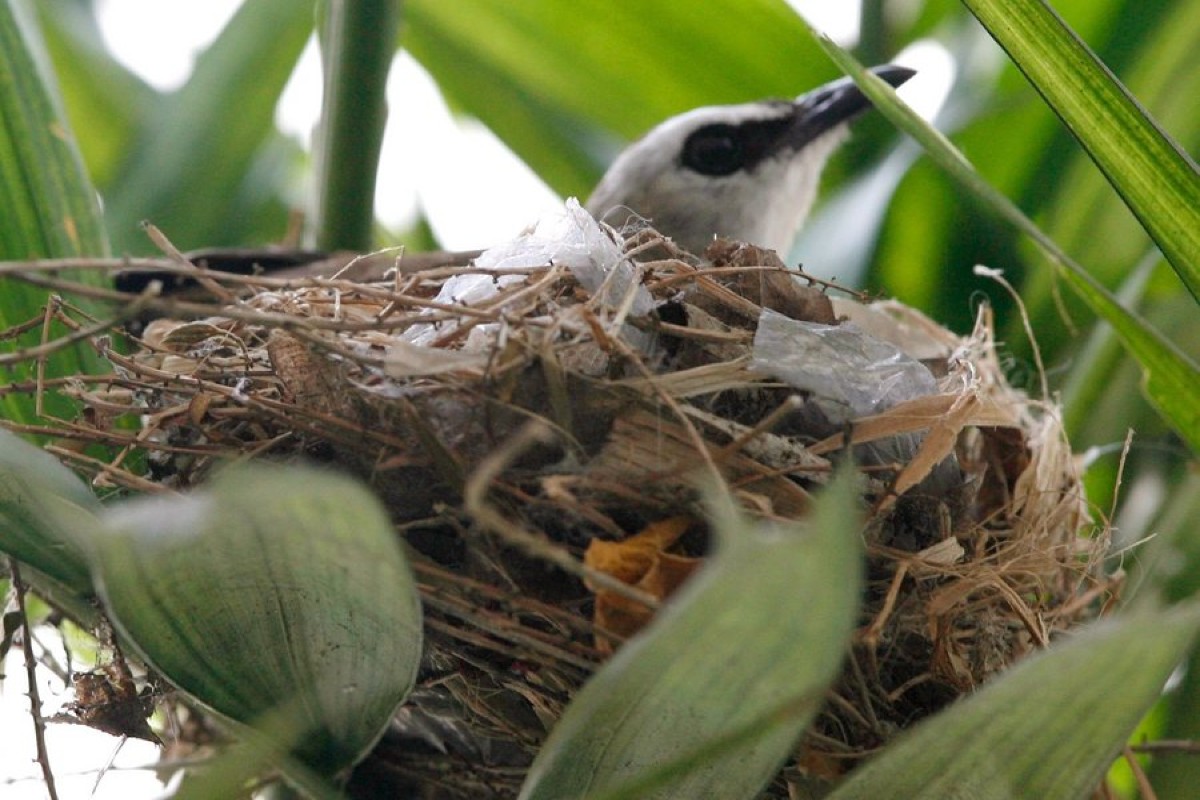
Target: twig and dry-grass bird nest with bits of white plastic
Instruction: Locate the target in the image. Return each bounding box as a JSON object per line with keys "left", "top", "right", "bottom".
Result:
{"left": 11, "top": 207, "right": 1111, "bottom": 798}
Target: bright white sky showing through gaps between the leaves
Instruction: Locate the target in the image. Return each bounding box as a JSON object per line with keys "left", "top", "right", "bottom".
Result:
{"left": 0, "top": 0, "right": 952, "bottom": 800}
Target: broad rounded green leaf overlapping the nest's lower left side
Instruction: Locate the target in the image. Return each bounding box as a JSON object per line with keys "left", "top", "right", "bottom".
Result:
{"left": 96, "top": 464, "right": 421, "bottom": 775}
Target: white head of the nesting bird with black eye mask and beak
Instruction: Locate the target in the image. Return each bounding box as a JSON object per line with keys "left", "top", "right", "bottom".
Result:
{"left": 586, "top": 65, "right": 916, "bottom": 255}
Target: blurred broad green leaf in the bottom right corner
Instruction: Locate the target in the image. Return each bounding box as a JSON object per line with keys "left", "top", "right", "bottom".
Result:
{"left": 829, "top": 604, "right": 1200, "bottom": 800}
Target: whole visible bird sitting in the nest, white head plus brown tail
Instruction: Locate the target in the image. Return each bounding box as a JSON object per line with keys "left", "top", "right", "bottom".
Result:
{"left": 114, "top": 64, "right": 916, "bottom": 293}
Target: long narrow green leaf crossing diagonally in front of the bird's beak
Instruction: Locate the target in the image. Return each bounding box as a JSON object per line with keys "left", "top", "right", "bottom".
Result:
{"left": 811, "top": 23, "right": 1200, "bottom": 452}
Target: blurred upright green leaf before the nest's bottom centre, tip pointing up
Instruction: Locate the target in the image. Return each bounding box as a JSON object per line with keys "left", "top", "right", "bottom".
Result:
{"left": 521, "top": 475, "right": 862, "bottom": 800}
